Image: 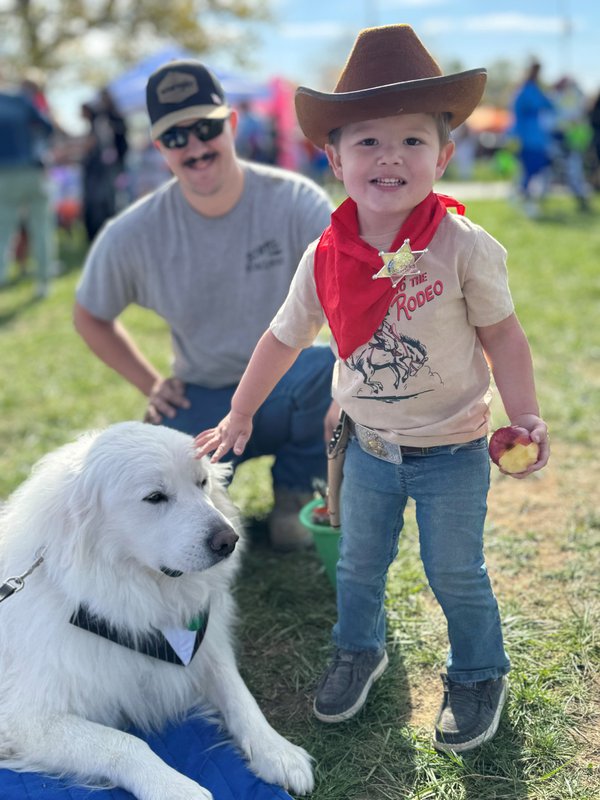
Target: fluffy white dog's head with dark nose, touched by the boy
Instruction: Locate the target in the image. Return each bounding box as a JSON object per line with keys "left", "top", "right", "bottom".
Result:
{"left": 80, "top": 422, "right": 239, "bottom": 577}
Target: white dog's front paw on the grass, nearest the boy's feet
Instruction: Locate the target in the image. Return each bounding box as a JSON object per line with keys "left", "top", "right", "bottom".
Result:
{"left": 249, "top": 734, "right": 315, "bottom": 794}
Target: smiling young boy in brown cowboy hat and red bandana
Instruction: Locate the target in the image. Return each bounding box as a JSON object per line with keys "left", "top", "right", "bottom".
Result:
{"left": 196, "top": 25, "right": 548, "bottom": 751}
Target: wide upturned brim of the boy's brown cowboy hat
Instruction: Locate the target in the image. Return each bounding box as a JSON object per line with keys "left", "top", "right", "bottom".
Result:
{"left": 296, "top": 68, "right": 487, "bottom": 149}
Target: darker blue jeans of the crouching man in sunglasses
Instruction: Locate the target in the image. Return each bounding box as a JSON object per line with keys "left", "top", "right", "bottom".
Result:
{"left": 163, "top": 345, "right": 334, "bottom": 492}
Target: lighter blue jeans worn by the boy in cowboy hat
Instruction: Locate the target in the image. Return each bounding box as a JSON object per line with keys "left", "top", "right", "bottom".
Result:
{"left": 333, "top": 437, "right": 510, "bottom": 683}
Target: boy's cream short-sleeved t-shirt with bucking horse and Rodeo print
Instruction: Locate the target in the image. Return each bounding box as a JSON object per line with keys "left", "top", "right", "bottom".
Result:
{"left": 270, "top": 213, "right": 514, "bottom": 447}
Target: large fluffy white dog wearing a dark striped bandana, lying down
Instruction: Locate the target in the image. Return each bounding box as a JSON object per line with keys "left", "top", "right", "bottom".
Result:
{"left": 0, "top": 422, "right": 313, "bottom": 800}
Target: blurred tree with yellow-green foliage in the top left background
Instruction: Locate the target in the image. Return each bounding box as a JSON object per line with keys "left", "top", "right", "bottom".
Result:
{"left": 0, "top": 0, "right": 270, "bottom": 79}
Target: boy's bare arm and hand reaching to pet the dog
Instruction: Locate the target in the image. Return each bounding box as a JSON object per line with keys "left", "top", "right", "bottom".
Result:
{"left": 195, "top": 330, "right": 301, "bottom": 461}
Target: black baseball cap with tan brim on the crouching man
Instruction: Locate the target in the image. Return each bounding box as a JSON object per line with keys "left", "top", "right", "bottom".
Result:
{"left": 146, "top": 60, "right": 231, "bottom": 139}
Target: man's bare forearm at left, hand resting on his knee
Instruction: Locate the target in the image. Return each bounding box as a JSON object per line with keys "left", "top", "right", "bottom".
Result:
{"left": 73, "top": 302, "right": 189, "bottom": 424}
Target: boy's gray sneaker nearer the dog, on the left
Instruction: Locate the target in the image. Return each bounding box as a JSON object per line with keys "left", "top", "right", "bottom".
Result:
{"left": 313, "top": 650, "right": 388, "bottom": 722}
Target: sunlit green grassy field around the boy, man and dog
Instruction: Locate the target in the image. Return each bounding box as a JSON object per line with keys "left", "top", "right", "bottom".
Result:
{"left": 0, "top": 198, "right": 600, "bottom": 800}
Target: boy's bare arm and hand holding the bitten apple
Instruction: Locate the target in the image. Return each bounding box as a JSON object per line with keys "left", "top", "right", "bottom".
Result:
{"left": 477, "top": 314, "right": 550, "bottom": 478}
